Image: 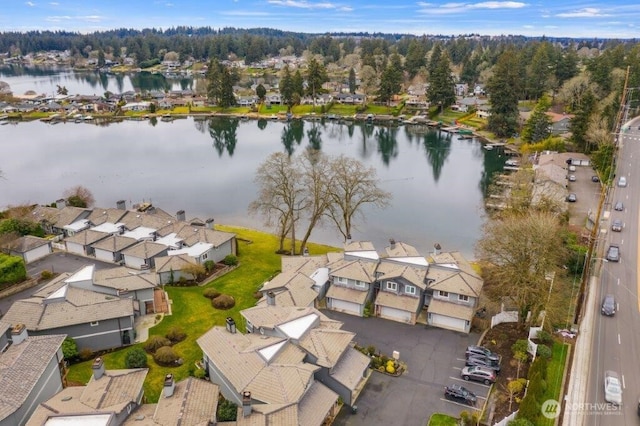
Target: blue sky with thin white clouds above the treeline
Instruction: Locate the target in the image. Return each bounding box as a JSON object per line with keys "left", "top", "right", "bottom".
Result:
{"left": 0, "top": 0, "right": 640, "bottom": 38}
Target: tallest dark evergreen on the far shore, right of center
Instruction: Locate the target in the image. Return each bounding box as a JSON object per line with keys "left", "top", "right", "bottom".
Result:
{"left": 487, "top": 48, "right": 521, "bottom": 137}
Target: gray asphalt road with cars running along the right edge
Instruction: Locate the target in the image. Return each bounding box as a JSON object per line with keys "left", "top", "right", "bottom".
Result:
{"left": 583, "top": 120, "right": 640, "bottom": 426}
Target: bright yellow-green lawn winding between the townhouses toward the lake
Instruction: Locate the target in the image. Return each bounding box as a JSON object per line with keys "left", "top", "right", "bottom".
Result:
{"left": 67, "top": 225, "right": 337, "bottom": 402}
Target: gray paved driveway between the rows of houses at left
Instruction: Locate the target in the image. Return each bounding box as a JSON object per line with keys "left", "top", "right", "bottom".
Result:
{"left": 0, "top": 252, "right": 119, "bottom": 315}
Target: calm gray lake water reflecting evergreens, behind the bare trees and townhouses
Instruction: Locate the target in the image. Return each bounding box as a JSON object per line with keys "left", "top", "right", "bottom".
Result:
{"left": 0, "top": 69, "right": 505, "bottom": 258}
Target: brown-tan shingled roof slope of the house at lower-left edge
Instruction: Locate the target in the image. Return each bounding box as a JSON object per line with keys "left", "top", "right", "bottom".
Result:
{"left": 0, "top": 336, "right": 66, "bottom": 422}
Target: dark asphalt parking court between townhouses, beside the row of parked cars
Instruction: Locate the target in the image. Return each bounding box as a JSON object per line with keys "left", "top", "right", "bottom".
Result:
{"left": 322, "top": 310, "right": 480, "bottom": 426}
